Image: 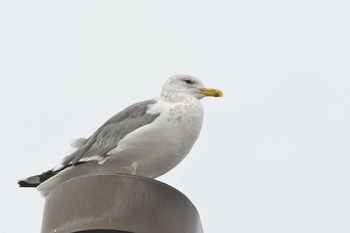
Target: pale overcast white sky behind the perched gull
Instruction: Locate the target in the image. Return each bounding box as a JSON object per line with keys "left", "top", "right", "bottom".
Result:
{"left": 0, "top": 0, "right": 350, "bottom": 233}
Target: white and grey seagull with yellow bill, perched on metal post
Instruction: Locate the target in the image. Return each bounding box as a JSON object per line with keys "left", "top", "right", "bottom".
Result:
{"left": 18, "top": 75, "right": 223, "bottom": 197}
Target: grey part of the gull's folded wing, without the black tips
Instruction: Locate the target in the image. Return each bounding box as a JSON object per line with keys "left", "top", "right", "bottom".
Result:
{"left": 59, "top": 100, "right": 160, "bottom": 170}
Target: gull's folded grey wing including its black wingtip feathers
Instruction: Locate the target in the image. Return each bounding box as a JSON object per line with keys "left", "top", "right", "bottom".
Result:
{"left": 18, "top": 100, "right": 160, "bottom": 187}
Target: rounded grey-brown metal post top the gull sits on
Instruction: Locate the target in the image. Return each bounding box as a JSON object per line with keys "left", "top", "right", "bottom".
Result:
{"left": 41, "top": 174, "right": 203, "bottom": 233}
